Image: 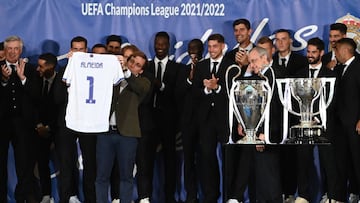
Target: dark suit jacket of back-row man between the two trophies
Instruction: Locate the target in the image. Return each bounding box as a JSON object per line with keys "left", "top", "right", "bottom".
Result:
{"left": 273, "top": 52, "right": 308, "bottom": 78}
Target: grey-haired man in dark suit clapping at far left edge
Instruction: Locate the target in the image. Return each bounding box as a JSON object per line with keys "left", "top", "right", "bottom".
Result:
{"left": 0, "top": 36, "right": 40, "bottom": 202}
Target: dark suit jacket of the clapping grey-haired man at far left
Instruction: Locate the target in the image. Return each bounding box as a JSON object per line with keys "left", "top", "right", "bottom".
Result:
{"left": 0, "top": 61, "right": 40, "bottom": 128}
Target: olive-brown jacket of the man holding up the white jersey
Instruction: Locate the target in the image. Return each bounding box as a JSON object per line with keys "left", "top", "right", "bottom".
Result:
{"left": 110, "top": 74, "right": 150, "bottom": 137}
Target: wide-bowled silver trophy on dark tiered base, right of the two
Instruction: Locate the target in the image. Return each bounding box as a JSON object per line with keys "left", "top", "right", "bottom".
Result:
{"left": 276, "top": 78, "right": 335, "bottom": 144}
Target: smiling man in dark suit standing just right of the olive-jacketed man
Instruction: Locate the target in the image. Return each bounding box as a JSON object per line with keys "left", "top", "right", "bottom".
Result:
{"left": 138, "top": 32, "right": 181, "bottom": 203}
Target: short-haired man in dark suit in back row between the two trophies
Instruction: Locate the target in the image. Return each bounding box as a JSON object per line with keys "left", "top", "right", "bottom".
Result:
{"left": 272, "top": 29, "right": 307, "bottom": 203}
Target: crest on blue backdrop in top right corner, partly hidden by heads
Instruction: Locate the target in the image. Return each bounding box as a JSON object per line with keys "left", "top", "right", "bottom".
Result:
{"left": 336, "top": 13, "right": 360, "bottom": 53}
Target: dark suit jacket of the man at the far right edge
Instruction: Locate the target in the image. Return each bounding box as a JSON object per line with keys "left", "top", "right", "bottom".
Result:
{"left": 336, "top": 58, "right": 360, "bottom": 130}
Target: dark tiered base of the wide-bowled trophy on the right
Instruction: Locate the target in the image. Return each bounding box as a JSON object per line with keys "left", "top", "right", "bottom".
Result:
{"left": 285, "top": 125, "right": 330, "bottom": 145}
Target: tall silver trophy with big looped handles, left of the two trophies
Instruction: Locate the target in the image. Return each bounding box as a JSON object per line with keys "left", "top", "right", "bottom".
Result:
{"left": 225, "top": 65, "right": 273, "bottom": 144}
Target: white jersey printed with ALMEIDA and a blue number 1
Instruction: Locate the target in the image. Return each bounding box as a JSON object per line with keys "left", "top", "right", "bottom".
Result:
{"left": 63, "top": 52, "right": 124, "bottom": 133}
